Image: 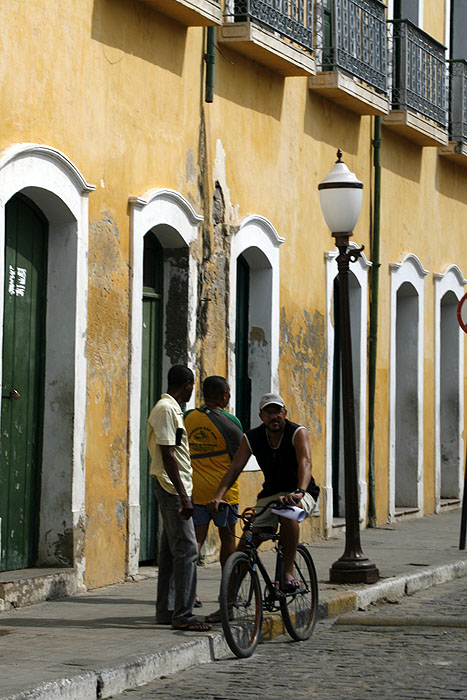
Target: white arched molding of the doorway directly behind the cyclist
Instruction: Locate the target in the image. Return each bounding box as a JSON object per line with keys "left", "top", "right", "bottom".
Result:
{"left": 229, "top": 215, "right": 285, "bottom": 469}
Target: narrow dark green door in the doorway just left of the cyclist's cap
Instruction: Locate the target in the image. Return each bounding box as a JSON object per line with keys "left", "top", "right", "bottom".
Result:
{"left": 235, "top": 255, "right": 251, "bottom": 430}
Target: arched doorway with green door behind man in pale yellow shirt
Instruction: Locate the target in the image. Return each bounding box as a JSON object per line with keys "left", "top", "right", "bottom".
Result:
{"left": 128, "top": 189, "right": 203, "bottom": 574}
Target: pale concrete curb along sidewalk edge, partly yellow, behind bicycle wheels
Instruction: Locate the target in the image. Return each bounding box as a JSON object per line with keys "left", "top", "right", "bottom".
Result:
{"left": 3, "top": 559, "right": 467, "bottom": 700}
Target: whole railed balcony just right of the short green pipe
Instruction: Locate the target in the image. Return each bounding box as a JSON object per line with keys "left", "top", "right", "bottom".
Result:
{"left": 217, "top": 0, "right": 314, "bottom": 76}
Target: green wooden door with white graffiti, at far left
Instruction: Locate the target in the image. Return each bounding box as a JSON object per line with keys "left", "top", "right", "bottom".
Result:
{"left": 0, "top": 196, "right": 48, "bottom": 571}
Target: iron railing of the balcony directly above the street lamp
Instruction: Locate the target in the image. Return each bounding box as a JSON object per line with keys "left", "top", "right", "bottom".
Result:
{"left": 321, "top": 0, "right": 387, "bottom": 94}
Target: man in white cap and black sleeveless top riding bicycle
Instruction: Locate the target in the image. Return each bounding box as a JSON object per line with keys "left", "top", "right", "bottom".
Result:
{"left": 207, "top": 394, "right": 319, "bottom": 590}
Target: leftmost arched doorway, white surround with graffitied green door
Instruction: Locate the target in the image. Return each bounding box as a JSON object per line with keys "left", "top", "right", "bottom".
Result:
{"left": 0, "top": 144, "right": 94, "bottom": 580}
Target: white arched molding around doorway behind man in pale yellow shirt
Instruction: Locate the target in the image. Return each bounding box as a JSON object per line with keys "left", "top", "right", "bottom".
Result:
{"left": 128, "top": 189, "right": 203, "bottom": 575}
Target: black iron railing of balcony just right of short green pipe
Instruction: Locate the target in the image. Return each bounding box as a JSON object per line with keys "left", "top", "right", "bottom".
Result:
{"left": 225, "top": 0, "right": 313, "bottom": 52}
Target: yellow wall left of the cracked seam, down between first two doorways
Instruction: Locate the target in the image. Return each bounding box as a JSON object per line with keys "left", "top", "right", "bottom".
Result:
{"left": 0, "top": 0, "right": 208, "bottom": 587}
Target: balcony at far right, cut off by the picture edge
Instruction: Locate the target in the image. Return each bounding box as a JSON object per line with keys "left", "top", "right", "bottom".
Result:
{"left": 439, "top": 59, "right": 467, "bottom": 166}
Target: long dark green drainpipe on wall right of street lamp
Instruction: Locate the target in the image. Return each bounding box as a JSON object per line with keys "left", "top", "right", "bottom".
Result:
{"left": 368, "top": 117, "right": 381, "bottom": 527}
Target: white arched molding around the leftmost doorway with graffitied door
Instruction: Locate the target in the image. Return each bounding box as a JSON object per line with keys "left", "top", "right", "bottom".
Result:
{"left": 0, "top": 143, "right": 95, "bottom": 590}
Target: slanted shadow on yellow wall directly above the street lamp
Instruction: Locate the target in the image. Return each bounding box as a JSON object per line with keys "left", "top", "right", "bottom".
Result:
{"left": 303, "top": 90, "right": 361, "bottom": 160}
